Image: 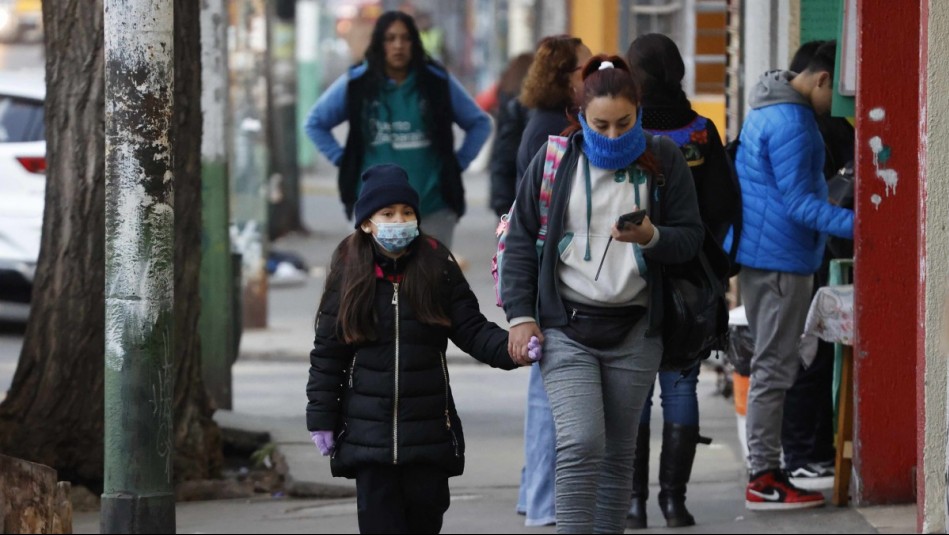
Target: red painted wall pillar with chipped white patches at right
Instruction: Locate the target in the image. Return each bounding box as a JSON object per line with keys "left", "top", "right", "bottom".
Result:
{"left": 854, "top": 0, "right": 924, "bottom": 504}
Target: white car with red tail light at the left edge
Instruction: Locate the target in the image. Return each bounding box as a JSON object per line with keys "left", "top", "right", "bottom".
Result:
{"left": 0, "top": 70, "right": 46, "bottom": 321}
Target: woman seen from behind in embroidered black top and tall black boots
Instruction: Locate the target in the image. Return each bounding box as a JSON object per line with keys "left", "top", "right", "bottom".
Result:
{"left": 626, "top": 33, "right": 741, "bottom": 529}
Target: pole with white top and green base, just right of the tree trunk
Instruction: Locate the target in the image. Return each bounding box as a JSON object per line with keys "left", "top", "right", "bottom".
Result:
{"left": 198, "top": 0, "right": 238, "bottom": 409}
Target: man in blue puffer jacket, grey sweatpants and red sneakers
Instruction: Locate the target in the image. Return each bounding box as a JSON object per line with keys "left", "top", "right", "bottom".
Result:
{"left": 725, "top": 41, "right": 853, "bottom": 510}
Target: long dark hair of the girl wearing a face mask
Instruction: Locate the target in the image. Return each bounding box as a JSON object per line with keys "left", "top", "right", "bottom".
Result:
{"left": 320, "top": 230, "right": 451, "bottom": 344}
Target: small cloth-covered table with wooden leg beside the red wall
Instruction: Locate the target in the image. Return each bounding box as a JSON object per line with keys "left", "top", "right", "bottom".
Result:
{"left": 801, "top": 284, "right": 854, "bottom": 506}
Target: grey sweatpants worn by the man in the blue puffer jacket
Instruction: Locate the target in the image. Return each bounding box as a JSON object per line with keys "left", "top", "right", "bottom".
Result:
{"left": 738, "top": 267, "right": 814, "bottom": 474}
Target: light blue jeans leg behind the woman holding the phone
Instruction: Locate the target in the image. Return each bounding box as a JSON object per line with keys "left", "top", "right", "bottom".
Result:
{"left": 517, "top": 364, "right": 557, "bottom": 526}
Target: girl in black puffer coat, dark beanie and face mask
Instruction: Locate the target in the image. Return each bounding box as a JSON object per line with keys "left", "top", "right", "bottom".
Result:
{"left": 306, "top": 164, "right": 530, "bottom": 533}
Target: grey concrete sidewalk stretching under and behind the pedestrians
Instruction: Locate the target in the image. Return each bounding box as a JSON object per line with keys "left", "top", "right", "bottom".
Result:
{"left": 74, "top": 173, "right": 916, "bottom": 533}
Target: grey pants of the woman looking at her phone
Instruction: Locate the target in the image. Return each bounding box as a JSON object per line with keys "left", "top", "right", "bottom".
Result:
{"left": 540, "top": 318, "right": 662, "bottom": 533}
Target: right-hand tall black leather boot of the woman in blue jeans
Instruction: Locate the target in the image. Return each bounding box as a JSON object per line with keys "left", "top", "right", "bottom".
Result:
{"left": 659, "top": 422, "right": 708, "bottom": 528}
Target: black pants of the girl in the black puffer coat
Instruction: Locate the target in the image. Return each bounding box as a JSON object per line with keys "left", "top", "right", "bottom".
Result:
{"left": 356, "top": 465, "right": 450, "bottom": 533}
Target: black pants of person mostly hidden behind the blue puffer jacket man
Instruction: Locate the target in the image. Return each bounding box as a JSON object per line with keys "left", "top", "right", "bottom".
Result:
{"left": 781, "top": 340, "right": 835, "bottom": 470}
